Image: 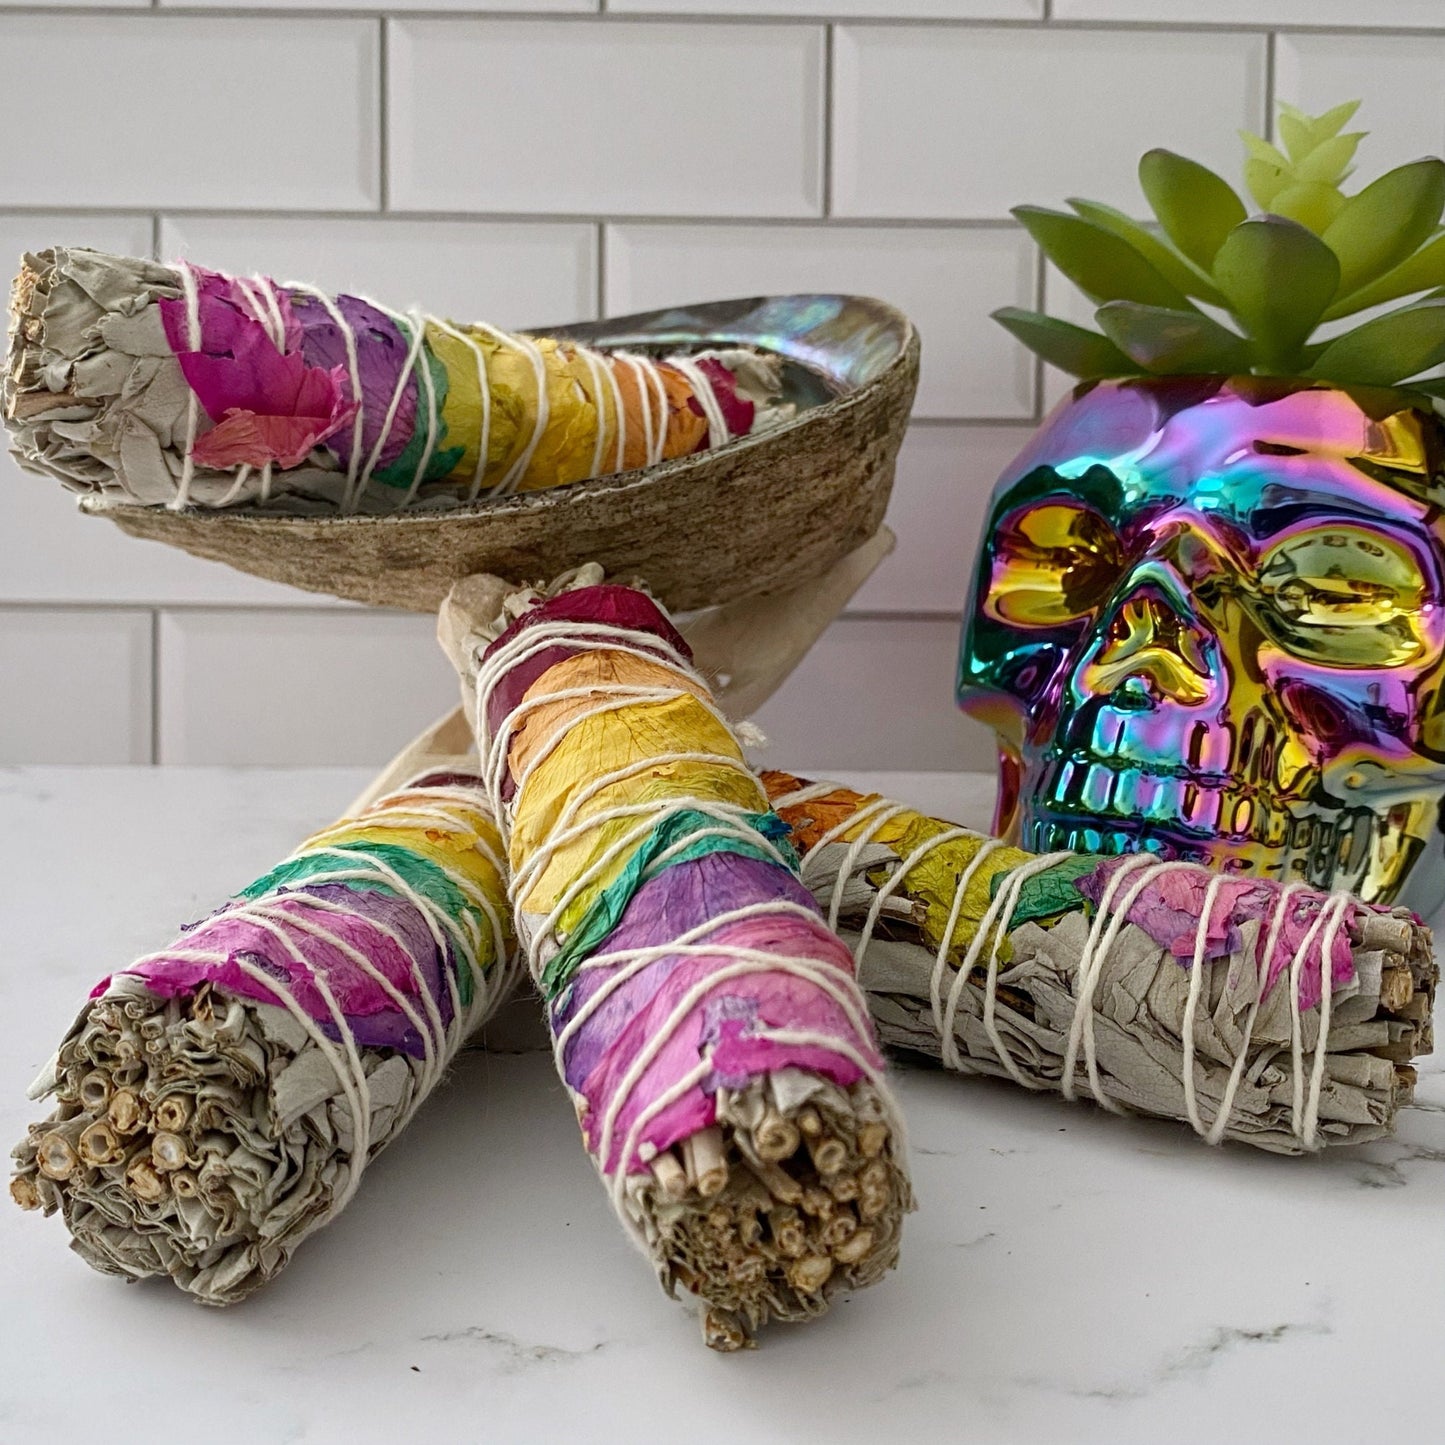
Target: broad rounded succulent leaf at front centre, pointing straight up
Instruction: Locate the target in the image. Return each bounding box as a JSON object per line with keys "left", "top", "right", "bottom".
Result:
{"left": 1214, "top": 215, "right": 1340, "bottom": 373}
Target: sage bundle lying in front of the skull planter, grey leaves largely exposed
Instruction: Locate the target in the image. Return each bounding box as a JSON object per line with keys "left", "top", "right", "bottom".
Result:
{"left": 764, "top": 773, "right": 1438, "bottom": 1153}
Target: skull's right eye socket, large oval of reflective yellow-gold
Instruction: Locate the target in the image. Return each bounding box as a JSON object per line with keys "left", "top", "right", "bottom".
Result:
{"left": 1259, "top": 526, "right": 1429, "bottom": 668}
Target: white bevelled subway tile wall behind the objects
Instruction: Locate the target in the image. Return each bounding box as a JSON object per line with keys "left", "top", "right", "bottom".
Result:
{"left": 0, "top": 11, "right": 1416, "bottom": 769}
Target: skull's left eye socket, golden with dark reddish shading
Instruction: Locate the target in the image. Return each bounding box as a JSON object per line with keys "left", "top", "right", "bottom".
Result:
{"left": 984, "top": 499, "right": 1123, "bottom": 627}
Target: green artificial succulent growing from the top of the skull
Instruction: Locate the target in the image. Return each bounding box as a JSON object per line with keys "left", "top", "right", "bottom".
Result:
{"left": 994, "top": 101, "right": 1445, "bottom": 397}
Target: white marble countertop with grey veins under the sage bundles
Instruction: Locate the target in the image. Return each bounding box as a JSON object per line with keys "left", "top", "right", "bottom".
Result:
{"left": 0, "top": 769, "right": 1445, "bottom": 1445}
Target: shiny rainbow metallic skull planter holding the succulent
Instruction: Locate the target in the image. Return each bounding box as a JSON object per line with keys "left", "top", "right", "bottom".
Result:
{"left": 959, "top": 377, "right": 1445, "bottom": 910}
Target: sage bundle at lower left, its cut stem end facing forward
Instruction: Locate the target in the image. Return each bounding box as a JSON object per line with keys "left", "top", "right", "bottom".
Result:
{"left": 10, "top": 772, "right": 513, "bottom": 1305}
